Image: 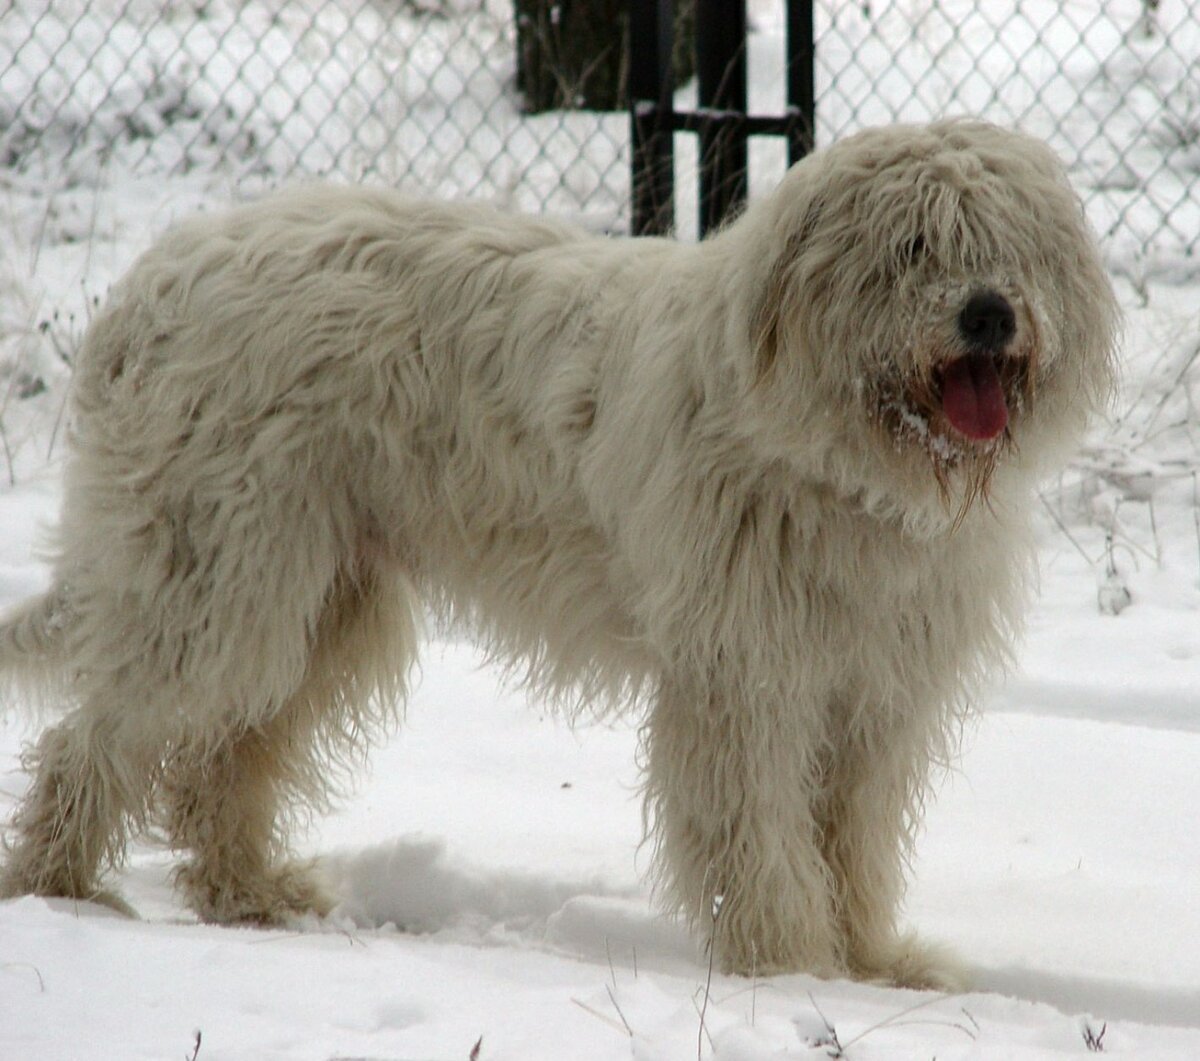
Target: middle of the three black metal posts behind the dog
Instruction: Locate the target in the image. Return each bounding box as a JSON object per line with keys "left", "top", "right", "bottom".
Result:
{"left": 696, "top": 0, "right": 749, "bottom": 235}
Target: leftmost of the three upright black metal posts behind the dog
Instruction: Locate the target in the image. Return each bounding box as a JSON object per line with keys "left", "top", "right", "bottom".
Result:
{"left": 629, "top": 0, "right": 674, "bottom": 235}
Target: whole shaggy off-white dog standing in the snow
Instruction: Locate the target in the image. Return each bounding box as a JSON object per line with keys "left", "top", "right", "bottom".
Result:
{"left": 0, "top": 122, "right": 1116, "bottom": 985}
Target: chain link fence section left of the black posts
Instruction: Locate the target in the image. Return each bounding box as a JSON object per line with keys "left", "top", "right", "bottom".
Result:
{"left": 0, "top": 0, "right": 629, "bottom": 223}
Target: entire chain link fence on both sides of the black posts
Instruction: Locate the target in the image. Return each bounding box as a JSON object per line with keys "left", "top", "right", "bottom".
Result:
{"left": 0, "top": 0, "right": 1200, "bottom": 272}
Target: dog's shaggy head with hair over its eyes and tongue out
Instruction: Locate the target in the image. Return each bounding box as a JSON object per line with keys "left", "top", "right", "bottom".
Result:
{"left": 730, "top": 121, "right": 1117, "bottom": 516}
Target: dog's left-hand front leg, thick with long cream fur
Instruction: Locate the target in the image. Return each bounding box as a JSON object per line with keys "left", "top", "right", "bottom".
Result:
{"left": 644, "top": 682, "right": 846, "bottom": 976}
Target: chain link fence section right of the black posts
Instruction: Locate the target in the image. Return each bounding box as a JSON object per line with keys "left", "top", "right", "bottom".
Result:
{"left": 817, "top": 0, "right": 1200, "bottom": 272}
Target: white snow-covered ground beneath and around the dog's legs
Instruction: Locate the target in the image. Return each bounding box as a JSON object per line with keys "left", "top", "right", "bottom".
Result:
{"left": 0, "top": 468, "right": 1200, "bottom": 1061}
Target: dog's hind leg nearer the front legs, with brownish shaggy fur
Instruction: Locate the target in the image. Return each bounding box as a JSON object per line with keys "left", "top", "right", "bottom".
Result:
{"left": 163, "top": 571, "right": 416, "bottom": 924}
